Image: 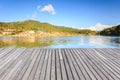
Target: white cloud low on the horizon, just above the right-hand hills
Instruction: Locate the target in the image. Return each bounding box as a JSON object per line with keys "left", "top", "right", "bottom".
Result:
{"left": 89, "top": 23, "right": 112, "bottom": 31}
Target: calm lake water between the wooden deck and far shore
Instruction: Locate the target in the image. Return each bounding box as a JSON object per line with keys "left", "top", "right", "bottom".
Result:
{"left": 0, "top": 36, "right": 120, "bottom": 48}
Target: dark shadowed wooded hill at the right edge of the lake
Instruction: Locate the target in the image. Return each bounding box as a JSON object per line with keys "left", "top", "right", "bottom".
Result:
{"left": 100, "top": 25, "right": 120, "bottom": 36}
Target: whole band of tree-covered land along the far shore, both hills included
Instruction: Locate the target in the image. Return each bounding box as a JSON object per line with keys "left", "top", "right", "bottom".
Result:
{"left": 0, "top": 20, "right": 120, "bottom": 36}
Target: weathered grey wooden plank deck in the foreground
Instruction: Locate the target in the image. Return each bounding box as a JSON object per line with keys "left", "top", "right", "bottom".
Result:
{"left": 0, "top": 47, "right": 120, "bottom": 80}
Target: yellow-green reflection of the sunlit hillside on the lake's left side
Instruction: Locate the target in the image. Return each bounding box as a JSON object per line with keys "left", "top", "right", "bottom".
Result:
{"left": 0, "top": 37, "right": 53, "bottom": 48}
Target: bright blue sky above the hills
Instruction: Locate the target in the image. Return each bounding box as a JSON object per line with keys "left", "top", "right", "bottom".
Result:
{"left": 0, "top": 0, "right": 120, "bottom": 28}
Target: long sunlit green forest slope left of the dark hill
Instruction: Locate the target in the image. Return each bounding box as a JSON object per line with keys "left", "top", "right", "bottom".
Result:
{"left": 0, "top": 20, "right": 97, "bottom": 35}
